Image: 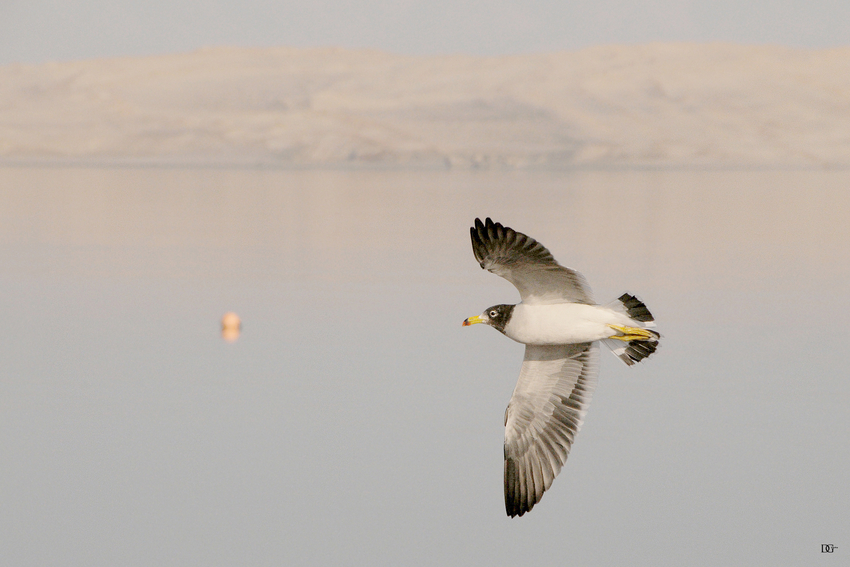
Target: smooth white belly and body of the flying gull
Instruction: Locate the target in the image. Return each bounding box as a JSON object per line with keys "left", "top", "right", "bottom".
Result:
{"left": 505, "top": 303, "right": 630, "bottom": 345}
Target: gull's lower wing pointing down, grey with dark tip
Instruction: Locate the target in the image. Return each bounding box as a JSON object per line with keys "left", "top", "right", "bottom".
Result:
{"left": 505, "top": 343, "right": 599, "bottom": 516}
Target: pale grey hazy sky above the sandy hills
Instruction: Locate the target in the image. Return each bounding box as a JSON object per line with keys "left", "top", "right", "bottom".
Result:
{"left": 0, "top": 0, "right": 850, "bottom": 64}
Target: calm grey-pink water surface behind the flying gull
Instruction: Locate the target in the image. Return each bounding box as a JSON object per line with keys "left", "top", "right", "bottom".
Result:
{"left": 0, "top": 168, "right": 850, "bottom": 567}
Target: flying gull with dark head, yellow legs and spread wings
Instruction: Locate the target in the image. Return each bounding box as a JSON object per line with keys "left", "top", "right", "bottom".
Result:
{"left": 463, "top": 218, "right": 661, "bottom": 517}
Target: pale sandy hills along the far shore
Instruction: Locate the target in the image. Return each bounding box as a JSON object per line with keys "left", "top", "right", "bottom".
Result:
{"left": 0, "top": 44, "right": 850, "bottom": 168}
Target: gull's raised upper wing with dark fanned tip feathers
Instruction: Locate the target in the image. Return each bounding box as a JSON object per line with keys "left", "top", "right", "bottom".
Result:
{"left": 469, "top": 218, "right": 593, "bottom": 304}
